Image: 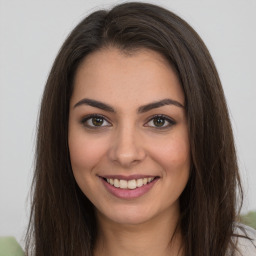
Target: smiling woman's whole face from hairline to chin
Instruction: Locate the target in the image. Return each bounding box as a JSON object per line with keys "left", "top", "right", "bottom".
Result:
{"left": 68, "top": 48, "right": 190, "bottom": 224}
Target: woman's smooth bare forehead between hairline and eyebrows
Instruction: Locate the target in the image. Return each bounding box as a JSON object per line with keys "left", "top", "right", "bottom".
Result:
{"left": 71, "top": 48, "right": 184, "bottom": 108}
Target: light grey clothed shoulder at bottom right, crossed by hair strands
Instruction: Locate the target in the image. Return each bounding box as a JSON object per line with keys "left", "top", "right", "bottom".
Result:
{"left": 234, "top": 223, "right": 256, "bottom": 256}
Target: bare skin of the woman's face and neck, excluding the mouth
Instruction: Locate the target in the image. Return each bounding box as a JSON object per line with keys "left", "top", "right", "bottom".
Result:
{"left": 68, "top": 48, "right": 190, "bottom": 256}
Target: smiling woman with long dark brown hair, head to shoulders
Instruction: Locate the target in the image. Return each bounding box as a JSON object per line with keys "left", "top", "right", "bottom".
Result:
{"left": 27, "top": 3, "right": 256, "bottom": 256}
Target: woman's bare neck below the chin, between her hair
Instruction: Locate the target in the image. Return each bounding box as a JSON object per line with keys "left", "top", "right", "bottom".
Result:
{"left": 94, "top": 207, "right": 183, "bottom": 256}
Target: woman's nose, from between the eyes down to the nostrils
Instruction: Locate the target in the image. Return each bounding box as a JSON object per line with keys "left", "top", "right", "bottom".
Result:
{"left": 109, "top": 124, "right": 146, "bottom": 168}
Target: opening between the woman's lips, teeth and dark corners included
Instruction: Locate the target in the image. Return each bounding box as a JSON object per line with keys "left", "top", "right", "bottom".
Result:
{"left": 102, "top": 177, "right": 159, "bottom": 190}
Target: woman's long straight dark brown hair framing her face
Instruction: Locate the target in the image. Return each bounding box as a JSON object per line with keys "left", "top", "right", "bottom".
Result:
{"left": 27, "top": 3, "right": 242, "bottom": 256}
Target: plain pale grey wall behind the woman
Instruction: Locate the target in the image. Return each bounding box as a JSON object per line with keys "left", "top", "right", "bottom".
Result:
{"left": 0, "top": 0, "right": 256, "bottom": 248}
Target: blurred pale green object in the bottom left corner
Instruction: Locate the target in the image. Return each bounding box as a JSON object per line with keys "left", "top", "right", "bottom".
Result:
{"left": 0, "top": 236, "right": 25, "bottom": 256}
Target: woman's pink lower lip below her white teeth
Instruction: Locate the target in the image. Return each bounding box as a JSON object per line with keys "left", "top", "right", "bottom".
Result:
{"left": 101, "top": 178, "right": 159, "bottom": 199}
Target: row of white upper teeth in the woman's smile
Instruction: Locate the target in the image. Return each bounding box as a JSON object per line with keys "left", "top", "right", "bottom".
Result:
{"left": 107, "top": 177, "right": 154, "bottom": 189}
